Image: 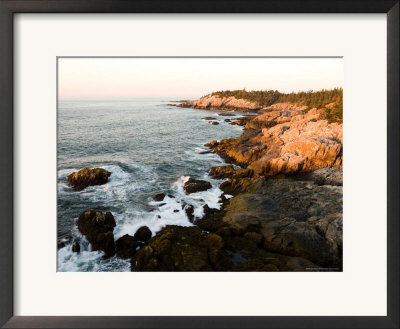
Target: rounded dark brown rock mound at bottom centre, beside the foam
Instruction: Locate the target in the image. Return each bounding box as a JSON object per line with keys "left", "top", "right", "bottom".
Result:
{"left": 132, "top": 225, "right": 229, "bottom": 271}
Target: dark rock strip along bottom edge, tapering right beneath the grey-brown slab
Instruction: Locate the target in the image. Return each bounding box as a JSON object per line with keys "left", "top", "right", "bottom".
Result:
{"left": 131, "top": 225, "right": 317, "bottom": 271}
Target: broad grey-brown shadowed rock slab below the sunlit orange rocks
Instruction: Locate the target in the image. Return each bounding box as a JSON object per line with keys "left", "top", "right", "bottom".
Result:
{"left": 222, "top": 179, "right": 342, "bottom": 267}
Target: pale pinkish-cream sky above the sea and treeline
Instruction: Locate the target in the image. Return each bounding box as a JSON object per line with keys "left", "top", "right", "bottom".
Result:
{"left": 58, "top": 58, "right": 343, "bottom": 100}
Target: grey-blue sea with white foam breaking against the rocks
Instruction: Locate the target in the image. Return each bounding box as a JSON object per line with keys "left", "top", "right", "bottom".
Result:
{"left": 57, "top": 99, "right": 242, "bottom": 271}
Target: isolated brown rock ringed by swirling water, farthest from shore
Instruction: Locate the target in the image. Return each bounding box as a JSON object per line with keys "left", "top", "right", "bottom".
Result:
{"left": 67, "top": 168, "right": 111, "bottom": 191}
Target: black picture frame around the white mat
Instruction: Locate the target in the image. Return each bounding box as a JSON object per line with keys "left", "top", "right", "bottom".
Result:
{"left": 0, "top": 0, "right": 400, "bottom": 328}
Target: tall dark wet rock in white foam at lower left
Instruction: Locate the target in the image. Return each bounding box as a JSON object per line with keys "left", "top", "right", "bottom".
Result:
{"left": 77, "top": 209, "right": 116, "bottom": 256}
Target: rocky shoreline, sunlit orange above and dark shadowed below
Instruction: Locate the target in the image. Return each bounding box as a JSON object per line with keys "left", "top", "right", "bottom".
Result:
{"left": 61, "top": 91, "right": 343, "bottom": 271}
